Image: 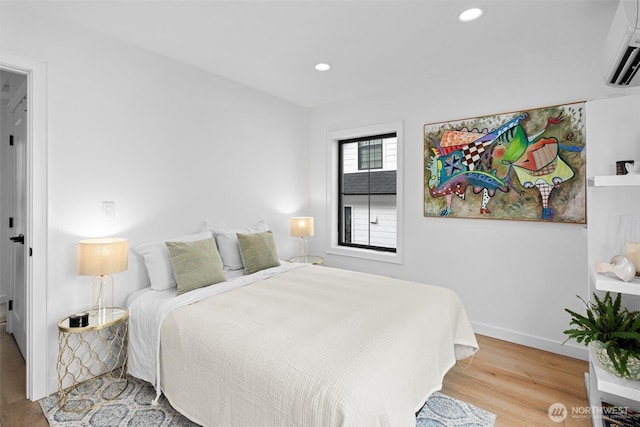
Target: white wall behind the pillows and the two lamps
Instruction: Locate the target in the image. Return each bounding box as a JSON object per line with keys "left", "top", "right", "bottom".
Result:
{"left": 0, "top": 3, "right": 309, "bottom": 393}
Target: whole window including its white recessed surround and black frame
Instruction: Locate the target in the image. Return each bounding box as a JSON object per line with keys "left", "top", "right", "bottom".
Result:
{"left": 326, "top": 122, "right": 403, "bottom": 264}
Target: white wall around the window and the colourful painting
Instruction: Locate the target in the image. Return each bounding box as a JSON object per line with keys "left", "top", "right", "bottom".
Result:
{"left": 310, "top": 37, "right": 630, "bottom": 358}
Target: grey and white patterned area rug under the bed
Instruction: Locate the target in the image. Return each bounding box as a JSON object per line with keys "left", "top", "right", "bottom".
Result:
{"left": 39, "top": 377, "right": 496, "bottom": 427}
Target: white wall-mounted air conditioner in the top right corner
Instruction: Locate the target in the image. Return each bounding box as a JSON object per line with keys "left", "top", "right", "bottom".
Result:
{"left": 602, "top": 0, "right": 640, "bottom": 87}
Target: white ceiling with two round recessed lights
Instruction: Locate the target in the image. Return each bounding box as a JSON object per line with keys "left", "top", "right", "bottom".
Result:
{"left": 20, "top": 0, "right": 617, "bottom": 108}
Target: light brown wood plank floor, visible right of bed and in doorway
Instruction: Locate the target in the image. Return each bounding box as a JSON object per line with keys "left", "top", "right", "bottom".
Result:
{"left": 0, "top": 318, "right": 591, "bottom": 427}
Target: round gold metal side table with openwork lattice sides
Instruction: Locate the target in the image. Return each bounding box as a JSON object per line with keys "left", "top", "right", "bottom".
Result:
{"left": 57, "top": 307, "right": 129, "bottom": 412}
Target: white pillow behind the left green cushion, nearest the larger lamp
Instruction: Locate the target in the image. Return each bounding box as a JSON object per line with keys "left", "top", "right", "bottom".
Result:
{"left": 135, "top": 230, "right": 213, "bottom": 291}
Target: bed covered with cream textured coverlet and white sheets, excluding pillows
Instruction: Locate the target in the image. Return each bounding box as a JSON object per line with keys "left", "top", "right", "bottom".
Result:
{"left": 128, "top": 226, "right": 478, "bottom": 427}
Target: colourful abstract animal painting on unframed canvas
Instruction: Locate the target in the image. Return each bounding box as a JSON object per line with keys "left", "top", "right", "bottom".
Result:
{"left": 424, "top": 102, "right": 586, "bottom": 224}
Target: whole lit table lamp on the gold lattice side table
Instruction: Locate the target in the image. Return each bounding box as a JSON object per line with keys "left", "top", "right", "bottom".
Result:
{"left": 78, "top": 238, "right": 129, "bottom": 311}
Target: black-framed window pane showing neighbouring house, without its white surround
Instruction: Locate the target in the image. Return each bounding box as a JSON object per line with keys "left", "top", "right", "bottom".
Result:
{"left": 338, "top": 133, "right": 397, "bottom": 252}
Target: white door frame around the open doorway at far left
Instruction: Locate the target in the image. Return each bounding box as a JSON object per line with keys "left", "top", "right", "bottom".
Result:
{"left": 0, "top": 52, "right": 49, "bottom": 401}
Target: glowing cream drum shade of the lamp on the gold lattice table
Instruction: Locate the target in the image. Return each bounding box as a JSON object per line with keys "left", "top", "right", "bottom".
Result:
{"left": 78, "top": 238, "right": 129, "bottom": 276}
